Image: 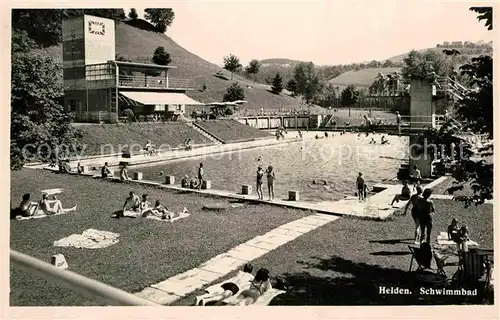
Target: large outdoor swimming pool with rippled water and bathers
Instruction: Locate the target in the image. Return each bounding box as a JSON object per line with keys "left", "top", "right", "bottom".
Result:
{"left": 131, "top": 132, "right": 408, "bottom": 201}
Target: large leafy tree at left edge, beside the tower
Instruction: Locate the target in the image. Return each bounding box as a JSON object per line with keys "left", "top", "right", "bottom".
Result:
{"left": 10, "top": 30, "right": 82, "bottom": 170}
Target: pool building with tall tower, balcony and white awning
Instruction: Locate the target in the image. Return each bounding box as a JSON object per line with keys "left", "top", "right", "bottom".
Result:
{"left": 62, "top": 15, "right": 201, "bottom": 123}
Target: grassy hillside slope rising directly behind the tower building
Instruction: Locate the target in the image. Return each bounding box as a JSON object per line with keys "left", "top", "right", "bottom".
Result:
{"left": 34, "top": 19, "right": 300, "bottom": 109}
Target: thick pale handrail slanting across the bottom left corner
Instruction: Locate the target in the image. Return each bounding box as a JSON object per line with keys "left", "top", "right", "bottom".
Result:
{"left": 10, "top": 250, "right": 159, "bottom": 306}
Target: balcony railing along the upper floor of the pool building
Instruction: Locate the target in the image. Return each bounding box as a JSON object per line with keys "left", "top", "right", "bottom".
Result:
{"left": 118, "top": 75, "right": 195, "bottom": 89}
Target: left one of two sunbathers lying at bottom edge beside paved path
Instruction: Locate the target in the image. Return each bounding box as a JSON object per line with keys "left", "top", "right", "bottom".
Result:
{"left": 196, "top": 263, "right": 254, "bottom": 306}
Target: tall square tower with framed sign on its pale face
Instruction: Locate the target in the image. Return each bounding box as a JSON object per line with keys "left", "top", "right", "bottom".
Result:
{"left": 62, "top": 15, "right": 115, "bottom": 121}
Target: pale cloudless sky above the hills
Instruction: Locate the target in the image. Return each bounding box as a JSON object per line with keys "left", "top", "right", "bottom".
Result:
{"left": 124, "top": 0, "right": 493, "bottom": 65}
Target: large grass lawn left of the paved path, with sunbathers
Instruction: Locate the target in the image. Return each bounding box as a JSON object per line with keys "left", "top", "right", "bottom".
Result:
{"left": 10, "top": 169, "right": 308, "bottom": 306}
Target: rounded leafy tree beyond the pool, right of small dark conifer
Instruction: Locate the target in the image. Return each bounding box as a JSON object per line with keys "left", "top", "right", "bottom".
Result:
{"left": 293, "top": 62, "right": 323, "bottom": 103}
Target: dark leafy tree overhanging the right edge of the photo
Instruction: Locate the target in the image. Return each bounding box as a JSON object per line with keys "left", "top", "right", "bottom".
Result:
{"left": 419, "top": 7, "right": 494, "bottom": 207}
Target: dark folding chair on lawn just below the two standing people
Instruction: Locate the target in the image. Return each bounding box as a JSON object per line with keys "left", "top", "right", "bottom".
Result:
{"left": 408, "top": 246, "right": 451, "bottom": 285}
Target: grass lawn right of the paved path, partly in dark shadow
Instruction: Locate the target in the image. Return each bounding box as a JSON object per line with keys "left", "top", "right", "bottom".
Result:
{"left": 176, "top": 200, "right": 493, "bottom": 305}
